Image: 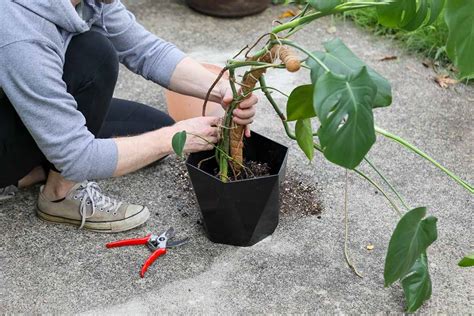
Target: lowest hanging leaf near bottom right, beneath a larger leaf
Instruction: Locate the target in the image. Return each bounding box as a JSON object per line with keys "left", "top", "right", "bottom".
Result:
{"left": 401, "top": 253, "right": 431, "bottom": 313}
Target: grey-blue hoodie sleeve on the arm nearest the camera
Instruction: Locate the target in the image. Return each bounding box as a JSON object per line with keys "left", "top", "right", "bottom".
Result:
{"left": 0, "top": 41, "right": 118, "bottom": 182}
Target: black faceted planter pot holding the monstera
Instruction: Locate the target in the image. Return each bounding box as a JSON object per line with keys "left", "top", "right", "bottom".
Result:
{"left": 186, "top": 132, "right": 288, "bottom": 246}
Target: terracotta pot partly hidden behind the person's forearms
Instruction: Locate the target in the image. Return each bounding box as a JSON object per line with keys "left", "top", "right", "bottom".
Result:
{"left": 165, "top": 64, "right": 228, "bottom": 121}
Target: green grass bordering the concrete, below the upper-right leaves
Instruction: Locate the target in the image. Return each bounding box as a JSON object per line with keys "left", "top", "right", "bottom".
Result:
{"left": 344, "top": 9, "right": 450, "bottom": 65}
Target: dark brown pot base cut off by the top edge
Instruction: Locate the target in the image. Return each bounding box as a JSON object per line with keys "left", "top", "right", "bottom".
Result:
{"left": 186, "top": 0, "right": 270, "bottom": 18}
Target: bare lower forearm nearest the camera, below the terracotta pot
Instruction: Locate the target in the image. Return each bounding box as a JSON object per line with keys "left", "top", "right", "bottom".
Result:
{"left": 114, "top": 127, "right": 176, "bottom": 177}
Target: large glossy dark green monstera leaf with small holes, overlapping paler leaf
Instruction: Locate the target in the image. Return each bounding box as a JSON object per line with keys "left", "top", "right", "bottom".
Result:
{"left": 314, "top": 67, "right": 377, "bottom": 169}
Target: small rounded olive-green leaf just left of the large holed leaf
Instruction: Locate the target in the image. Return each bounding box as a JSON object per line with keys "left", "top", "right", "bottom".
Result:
{"left": 286, "top": 84, "right": 316, "bottom": 121}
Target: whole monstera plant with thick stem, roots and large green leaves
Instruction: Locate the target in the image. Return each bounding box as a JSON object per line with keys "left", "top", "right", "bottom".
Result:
{"left": 173, "top": 0, "right": 474, "bottom": 312}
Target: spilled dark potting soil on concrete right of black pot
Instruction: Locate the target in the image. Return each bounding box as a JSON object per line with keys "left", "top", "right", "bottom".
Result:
{"left": 280, "top": 174, "right": 324, "bottom": 218}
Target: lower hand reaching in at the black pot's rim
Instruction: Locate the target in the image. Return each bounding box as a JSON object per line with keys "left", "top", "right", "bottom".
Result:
{"left": 171, "top": 116, "right": 221, "bottom": 153}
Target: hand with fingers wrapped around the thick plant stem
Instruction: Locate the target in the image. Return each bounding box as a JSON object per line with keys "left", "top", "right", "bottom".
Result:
{"left": 220, "top": 80, "right": 258, "bottom": 137}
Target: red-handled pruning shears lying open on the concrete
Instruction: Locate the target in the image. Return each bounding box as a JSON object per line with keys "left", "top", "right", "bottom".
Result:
{"left": 105, "top": 227, "right": 189, "bottom": 278}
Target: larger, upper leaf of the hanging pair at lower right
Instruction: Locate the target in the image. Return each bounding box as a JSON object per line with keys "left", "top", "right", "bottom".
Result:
{"left": 384, "top": 207, "right": 438, "bottom": 286}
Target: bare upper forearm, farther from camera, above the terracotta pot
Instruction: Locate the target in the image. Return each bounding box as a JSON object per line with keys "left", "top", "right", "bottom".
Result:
{"left": 169, "top": 57, "right": 224, "bottom": 103}
